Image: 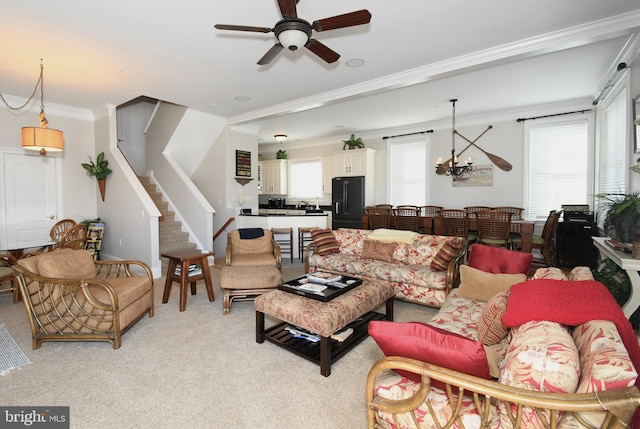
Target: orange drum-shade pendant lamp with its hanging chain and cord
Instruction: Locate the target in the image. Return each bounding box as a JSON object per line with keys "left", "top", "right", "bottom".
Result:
{"left": 0, "top": 59, "right": 64, "bottom": 156}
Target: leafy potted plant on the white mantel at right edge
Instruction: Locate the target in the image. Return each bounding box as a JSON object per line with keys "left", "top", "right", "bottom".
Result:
{"left": 596, "top": 192, "right": 640, "bottom": 243}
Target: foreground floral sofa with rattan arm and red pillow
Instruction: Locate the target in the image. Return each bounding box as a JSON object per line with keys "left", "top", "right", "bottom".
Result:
{"left": 367, "top": 266, "right": 640, "bottom": 429}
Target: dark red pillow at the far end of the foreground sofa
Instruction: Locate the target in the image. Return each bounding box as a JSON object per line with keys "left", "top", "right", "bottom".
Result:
{"left": 468, "top": 243, "right": 533, "bottom": 275}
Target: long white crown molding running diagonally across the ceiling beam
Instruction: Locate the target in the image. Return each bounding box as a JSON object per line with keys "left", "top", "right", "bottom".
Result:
{"left": 228, "top": 11, "right": 640, "bottom": 125}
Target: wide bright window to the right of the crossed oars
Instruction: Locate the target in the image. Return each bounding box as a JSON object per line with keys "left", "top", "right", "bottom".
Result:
{"left": 525, "top": 115, "right": 591, "bottom": 220}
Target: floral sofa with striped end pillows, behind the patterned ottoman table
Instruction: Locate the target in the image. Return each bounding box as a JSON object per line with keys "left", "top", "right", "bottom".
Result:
{"left": 305, "top": 228, "right": 466, "bottom": 307}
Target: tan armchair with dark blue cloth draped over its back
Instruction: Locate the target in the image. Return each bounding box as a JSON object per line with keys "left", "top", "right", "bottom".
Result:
{"left": 225, "top": 228, "right": 282, "bottom": 271}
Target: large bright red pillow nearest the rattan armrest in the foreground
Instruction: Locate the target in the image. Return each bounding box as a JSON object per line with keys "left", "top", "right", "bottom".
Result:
{"left": 369, "top": 321, "right": 491, "bottom": 382}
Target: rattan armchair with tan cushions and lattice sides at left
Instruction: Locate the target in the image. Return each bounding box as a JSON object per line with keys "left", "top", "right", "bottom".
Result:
{"left": 13, "top": 249, "right": 153, "bottom": 349}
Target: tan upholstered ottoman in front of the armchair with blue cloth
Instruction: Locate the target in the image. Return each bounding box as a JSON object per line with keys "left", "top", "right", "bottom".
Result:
{"left": 220, "top": 265, "right": 282, "bottom": 314}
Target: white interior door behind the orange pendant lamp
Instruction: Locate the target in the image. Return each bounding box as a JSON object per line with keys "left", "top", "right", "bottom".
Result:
{"left": 0, "top": 153, "right": 61, "bottom": 249}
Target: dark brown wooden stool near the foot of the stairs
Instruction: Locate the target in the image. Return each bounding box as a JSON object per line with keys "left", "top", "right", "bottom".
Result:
{"left": 161, "top": 249, "right": 216, "bottom": 311}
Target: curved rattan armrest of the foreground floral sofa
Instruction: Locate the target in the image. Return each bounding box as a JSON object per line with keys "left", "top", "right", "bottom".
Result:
{"left": 366, "top": 356, "right": 640, "bottom": 428}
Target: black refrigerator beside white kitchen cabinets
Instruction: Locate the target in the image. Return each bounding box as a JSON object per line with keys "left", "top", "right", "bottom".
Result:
{"left": 331, "top": 176, "right": 364, "bottom": 229}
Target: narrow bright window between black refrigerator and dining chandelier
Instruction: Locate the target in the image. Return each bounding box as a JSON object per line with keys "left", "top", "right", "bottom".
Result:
{"left": 388, "top": 137, "right": 427, "bottom": 206}
